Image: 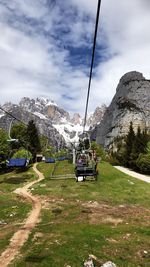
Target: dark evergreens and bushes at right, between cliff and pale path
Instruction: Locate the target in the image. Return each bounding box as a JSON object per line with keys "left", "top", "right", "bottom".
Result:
{"left": 111, "top": 122, "right": 150, "bottom": 174}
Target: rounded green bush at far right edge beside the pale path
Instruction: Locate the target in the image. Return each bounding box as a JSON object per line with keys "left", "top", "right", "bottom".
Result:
{"left": 136, "top": 154, "right": 150, "bottom": 174}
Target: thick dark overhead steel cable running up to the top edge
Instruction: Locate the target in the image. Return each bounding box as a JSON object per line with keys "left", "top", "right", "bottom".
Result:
{"left": 83, "top": 0, "right": 101, "bottom": 132}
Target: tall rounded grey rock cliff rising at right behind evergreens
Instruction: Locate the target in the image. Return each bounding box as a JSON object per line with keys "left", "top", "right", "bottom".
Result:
{"left": 96, "top": 71, "right": 150, "bottom": 148}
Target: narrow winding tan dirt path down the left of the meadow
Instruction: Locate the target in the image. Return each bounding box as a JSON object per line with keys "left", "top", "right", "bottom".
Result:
{"left": 0, "top": 163, "right": 44, "bottom": 267}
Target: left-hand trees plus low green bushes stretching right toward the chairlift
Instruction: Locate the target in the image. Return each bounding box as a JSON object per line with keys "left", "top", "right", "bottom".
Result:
{"left": 0, "top": 120, "right": 68, "bottom": 169}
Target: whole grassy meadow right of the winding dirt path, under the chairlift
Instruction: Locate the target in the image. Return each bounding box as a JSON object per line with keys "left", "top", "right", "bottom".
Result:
{"left": 7, "top": 162, "right": 150, "bottom": 267}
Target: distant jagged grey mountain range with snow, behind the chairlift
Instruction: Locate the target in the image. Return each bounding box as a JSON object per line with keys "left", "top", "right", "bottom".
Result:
{"left": 0, "top": 97, "right": 105, "bottom": 147}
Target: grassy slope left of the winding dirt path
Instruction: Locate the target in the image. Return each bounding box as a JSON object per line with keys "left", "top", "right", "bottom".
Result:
{"left": 0, "top": 168, "right": 36, "bottom": 255}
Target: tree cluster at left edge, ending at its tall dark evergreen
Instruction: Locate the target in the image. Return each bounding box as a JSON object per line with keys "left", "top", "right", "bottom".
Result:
{"left": 0, "top": 120, "right": 41, "bottom": 162}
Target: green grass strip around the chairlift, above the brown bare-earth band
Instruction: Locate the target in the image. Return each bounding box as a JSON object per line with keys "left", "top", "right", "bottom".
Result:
{"left": 35, "top": 162, "right": 150, "bottom": 207}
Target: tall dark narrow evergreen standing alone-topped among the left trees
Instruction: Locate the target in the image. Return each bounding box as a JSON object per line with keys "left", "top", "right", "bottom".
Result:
{"left": 27, "top": 120, "right": 41, "bottom": 161}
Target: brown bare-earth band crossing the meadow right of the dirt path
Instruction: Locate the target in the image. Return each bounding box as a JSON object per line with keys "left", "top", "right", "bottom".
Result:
{"left": 39, "top": 196, "right": 150, "bottom": 226}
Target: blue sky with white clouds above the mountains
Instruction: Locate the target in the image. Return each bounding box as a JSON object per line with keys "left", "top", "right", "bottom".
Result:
{"left": 0, "top": 0, "right": 150, "bottom": 114}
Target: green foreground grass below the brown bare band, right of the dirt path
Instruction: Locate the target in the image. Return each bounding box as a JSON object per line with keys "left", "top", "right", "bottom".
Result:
{"left": 12, "top": 224, "right": 149, "bottom": 267}
